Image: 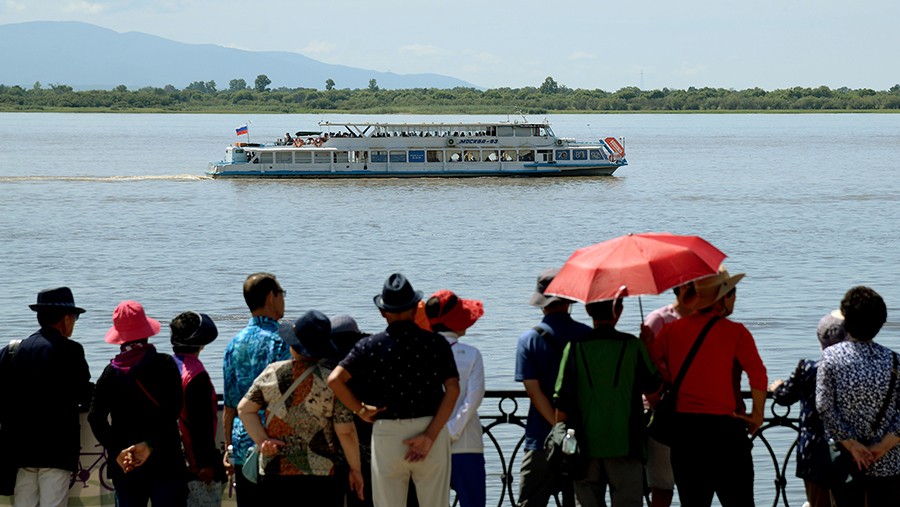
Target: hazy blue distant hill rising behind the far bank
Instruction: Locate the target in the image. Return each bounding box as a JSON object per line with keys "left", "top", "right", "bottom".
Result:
{"left": 0, "top": 21, "right": 475, "bottom": 91}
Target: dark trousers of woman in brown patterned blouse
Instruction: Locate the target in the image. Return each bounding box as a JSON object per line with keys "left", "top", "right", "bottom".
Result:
{"left": 259, "top": 475, "right": 345, "bottom": 507}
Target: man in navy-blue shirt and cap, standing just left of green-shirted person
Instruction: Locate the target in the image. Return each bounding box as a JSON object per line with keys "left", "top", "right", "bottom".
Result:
{"left": 516, "top": 268, "right": 591, "bottom": 507}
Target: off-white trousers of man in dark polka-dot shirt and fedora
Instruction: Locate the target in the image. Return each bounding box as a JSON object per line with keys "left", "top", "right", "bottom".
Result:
{"left": 372, "top": 417, "right": 450, "bottom": 507}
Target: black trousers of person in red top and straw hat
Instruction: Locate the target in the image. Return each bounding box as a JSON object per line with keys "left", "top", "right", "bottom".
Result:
{"left": 672, "top": 413, "right": 754, "bottom": 507}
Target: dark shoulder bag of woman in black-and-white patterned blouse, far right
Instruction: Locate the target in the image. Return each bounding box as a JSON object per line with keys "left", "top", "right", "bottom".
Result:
{"left": 813, "top": 352, "right": 900, "bottom": 489}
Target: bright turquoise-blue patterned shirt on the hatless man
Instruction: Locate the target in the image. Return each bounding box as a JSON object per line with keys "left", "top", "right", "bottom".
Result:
{"left": 224, "top": 317, "right": 291, "bottom": 465}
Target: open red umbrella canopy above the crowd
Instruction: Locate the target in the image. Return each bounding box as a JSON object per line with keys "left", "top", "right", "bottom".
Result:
{"left": 545, "top": 232, "right": 726, "bottom": 303}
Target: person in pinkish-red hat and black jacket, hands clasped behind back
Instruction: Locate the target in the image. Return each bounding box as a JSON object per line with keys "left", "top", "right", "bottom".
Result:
{"left": 88, "top": 301, "right": 184, "bottom": 507}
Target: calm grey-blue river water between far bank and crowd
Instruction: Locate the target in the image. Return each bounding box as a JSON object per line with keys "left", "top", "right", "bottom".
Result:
{"left": 0, "top": 113, "right": 900, "bottom": 505}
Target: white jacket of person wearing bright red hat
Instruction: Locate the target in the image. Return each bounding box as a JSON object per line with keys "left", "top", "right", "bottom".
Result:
{"left": 440, "top": 331, "right": 484, "bottom": 454}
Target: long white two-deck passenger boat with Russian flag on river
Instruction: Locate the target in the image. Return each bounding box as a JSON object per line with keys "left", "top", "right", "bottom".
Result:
{"left": 206, "top": 117, "right": 627, "bottom": 178}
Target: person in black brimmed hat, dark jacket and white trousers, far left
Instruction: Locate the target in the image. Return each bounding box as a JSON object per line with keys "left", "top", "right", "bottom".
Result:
{"left": 0, "top": 287, "right": 93, "bottom": 507}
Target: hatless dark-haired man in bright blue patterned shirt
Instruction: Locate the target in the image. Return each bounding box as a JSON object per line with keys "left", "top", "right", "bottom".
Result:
{"left": 222, "top": 273, "right": 291, "bottom": 507}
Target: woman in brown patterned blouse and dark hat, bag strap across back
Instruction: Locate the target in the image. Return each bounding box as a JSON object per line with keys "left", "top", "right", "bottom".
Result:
{"left": 237, "top": 310, "right": 363, "bottom": 507}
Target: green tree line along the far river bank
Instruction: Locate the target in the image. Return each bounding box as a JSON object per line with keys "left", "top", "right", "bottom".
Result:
{"left": 0, "top": 74, "right": 900, "bottom": 114}
